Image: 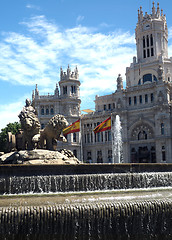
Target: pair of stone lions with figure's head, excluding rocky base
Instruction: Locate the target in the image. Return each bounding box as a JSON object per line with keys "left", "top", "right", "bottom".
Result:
{"left": 19, "top": 99, "right": 68, "bottom": 150}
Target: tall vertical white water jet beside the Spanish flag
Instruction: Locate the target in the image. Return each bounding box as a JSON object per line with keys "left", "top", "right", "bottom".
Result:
{"left": 112, "top": 115, "right": 122, "bottom": 163}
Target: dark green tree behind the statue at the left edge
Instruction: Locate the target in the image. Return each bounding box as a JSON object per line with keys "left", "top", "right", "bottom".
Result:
{"left": 0, "top": 122, "right": 21, "bottom": 152}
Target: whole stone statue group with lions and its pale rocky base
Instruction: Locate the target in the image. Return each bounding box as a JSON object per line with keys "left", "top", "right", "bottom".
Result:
{"left": 0, "top": 99, "right": 80, "bottom": 164}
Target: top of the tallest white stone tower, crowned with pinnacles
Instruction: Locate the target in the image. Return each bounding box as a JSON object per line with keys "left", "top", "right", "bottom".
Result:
{"left": 135, "top": 2, "right": 168, "bottom": 63}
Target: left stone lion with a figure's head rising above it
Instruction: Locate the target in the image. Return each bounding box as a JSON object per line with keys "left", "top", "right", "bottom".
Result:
{"left": 18, "top": 98, "right": 40, "bottom": 150}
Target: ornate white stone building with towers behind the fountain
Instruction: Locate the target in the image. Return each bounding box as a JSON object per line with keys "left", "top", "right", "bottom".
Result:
{"left": 33, "top": 3, "right": 172, "bottom": 163}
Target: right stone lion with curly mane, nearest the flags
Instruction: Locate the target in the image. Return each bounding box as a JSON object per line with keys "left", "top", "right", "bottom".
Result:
{"left": 40, "top": 114, "right": 68, "bottom": 150}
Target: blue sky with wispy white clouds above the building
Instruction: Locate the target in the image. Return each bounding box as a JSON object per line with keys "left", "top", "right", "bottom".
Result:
{"left": 0, "top": 0, "right": 172, "bottom": 129}
